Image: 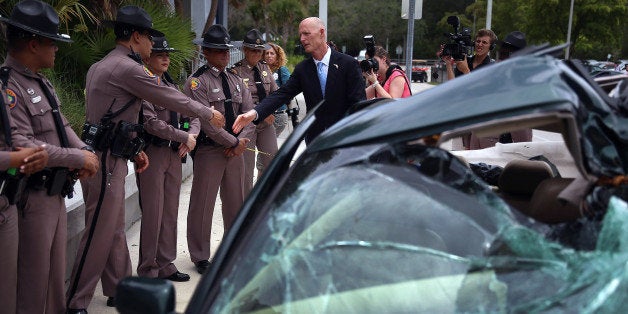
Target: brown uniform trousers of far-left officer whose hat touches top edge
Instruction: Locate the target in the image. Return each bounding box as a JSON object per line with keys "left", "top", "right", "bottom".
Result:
{"left": 17, "top": 190, "right": 68, "bottom": 313}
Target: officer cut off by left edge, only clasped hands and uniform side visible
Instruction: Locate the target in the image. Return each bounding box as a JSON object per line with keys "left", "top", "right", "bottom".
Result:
{"left": 0, "top": 55, "right": 48, "bottom": 313}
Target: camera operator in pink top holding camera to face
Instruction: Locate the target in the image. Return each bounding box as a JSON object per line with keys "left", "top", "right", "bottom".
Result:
{"left": 362, "top": 46, "right": 412, "bottom": 99}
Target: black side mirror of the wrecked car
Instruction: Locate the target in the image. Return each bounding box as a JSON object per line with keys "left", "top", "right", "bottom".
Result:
{"left": 116, "top": 277, "right": 175, "bottom": 314}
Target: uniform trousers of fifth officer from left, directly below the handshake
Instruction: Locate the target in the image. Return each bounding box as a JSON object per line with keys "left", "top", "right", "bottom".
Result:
{"left": 187, "top": 145, "right": 244, "bottom": 263}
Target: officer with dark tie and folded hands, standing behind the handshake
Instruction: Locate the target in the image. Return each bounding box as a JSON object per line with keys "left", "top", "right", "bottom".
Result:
{"left": 183, "top": 25, "right": 254, "bottom": 274}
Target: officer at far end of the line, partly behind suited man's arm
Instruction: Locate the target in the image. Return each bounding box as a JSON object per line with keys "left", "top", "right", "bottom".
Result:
{"left": 233, "top": 29, "right": 278, "bottom": 195}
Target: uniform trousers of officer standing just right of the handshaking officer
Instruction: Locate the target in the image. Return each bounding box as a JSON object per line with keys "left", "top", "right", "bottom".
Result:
{"left": 137, "top": 145, "right": 181, "bottom": 278}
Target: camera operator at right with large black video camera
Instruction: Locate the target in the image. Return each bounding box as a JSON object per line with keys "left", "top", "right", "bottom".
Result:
{"left": 437, "top": 29, "right": 497, "bottom": 80}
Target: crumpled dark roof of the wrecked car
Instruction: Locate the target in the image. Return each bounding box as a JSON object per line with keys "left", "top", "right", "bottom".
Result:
{"left": 308, "top": 55, "right": 628, "bottom": 177}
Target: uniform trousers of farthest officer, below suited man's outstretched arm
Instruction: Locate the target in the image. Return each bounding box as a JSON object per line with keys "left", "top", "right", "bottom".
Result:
{"left": 243, "top": 122, "right": 277, "bottom": 195}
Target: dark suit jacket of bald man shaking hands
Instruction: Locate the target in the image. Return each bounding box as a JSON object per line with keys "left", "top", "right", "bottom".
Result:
{"left": 254, "top": 50, "right": 366, "bottom": 143}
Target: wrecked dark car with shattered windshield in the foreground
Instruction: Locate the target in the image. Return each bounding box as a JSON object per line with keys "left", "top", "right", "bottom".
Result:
{"left": 116, "top": 48, "right": 628, "bottom": 313}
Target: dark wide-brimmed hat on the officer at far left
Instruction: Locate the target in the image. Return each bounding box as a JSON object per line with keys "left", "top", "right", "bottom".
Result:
{"left": 0, "top": 0, "right": 72, "bottom": 43}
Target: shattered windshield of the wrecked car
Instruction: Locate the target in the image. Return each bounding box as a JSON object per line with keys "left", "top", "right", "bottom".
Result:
{"left": 213, "top": 144, "right": 628, "bottom": 313}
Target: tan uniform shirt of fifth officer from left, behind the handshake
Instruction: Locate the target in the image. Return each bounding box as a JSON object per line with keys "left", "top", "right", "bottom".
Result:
{"left": 183, "top": 66, "right": 255, "bottom": 147}
